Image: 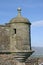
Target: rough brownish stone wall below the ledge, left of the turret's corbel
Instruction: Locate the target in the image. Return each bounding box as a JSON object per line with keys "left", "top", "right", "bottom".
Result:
{"left": 0, "top": 54, "right": 16, "bottom": 65}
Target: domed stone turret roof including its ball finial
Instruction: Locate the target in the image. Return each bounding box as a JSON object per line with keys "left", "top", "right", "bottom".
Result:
{"left": 10, "top": 8, "right": 31, "bottom": 24}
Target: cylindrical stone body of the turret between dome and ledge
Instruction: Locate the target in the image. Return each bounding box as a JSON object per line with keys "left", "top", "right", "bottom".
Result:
{"left": 10, "top": 23, "right": 31, "bottom": 51}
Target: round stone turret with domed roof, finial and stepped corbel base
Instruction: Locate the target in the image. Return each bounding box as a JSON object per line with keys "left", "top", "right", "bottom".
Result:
{"left": 9, "top": 8, "right": 33, "bottom": 61}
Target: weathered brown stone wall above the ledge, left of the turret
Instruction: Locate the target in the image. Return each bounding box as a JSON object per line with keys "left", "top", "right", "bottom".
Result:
{"left": 0, "top": 27, "right": 10, "bottom": 52}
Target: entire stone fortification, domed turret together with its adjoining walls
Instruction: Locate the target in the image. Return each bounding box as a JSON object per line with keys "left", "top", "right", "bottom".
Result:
{"left": 0, "top": 8, "right": 33, "bottom": 65}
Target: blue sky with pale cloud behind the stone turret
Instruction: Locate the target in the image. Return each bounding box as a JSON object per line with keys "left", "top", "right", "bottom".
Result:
{"left": 0, "top": 0, "right": 43, "bottom": 47}
